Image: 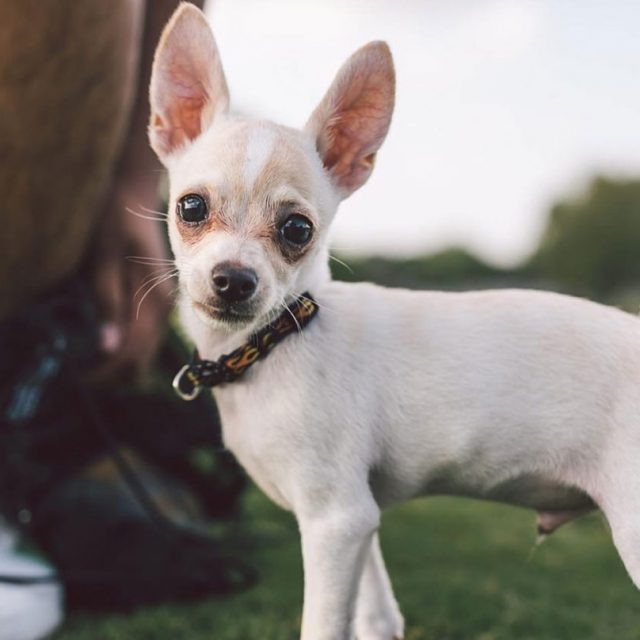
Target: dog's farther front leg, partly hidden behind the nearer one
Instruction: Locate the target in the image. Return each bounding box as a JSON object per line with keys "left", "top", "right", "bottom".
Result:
{"left": 355, "top": 533, "right": 404, "bottom": 640}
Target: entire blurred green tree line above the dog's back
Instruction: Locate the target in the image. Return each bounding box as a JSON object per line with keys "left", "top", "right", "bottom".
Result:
{"left": 332, "top": 177, "right": 640, "bottom": 310}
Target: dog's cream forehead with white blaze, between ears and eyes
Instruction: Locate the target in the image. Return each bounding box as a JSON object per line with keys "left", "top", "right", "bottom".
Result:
{"left": 176, "top": 120, "right": 316, "bottom": 208}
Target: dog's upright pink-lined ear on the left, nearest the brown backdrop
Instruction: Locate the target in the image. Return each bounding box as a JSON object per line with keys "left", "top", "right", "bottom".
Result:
{"left": 149, "top": 2, "right": 229, "bottom": 164}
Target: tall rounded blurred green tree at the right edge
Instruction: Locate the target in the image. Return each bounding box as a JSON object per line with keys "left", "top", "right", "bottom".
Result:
{"left": 530, "top": 177, "right": 640, "bottom": 300}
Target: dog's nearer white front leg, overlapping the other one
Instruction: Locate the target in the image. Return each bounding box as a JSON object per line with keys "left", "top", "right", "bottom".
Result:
{"left": 298, "top": 495, "right": 380, "bottom": 640}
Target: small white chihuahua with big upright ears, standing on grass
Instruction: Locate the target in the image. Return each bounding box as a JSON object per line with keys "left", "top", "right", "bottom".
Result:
{"left": 149, "top": 4, "right": 640, "bottom": 640}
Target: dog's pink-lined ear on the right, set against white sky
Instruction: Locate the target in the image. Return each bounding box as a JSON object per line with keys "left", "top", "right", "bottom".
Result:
{"left": 305, "top": 42, "right": 395, "bottom": 198}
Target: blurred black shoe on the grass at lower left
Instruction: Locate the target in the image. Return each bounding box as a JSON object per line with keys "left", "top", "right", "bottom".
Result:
{"left": 32, "top": 462, "right": 256, "bottom": 611}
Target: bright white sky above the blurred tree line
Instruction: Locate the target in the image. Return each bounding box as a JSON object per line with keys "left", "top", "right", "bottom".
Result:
{"left": 207, "top": 0, "right": 640, "bottom": 265}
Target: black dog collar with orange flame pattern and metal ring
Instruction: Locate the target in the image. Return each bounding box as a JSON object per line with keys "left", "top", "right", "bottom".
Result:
{"left": 173, "top": 293, "right": 318, "bottom": 400}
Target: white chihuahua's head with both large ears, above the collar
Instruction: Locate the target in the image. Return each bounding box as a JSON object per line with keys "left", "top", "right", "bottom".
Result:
{"left": 149, "top": 3, "right": 394, "bottom": 331}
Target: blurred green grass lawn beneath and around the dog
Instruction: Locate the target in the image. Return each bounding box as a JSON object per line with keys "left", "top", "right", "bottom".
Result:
{"left": 55, "top": 491, "right": 640, "bottom": 640}
